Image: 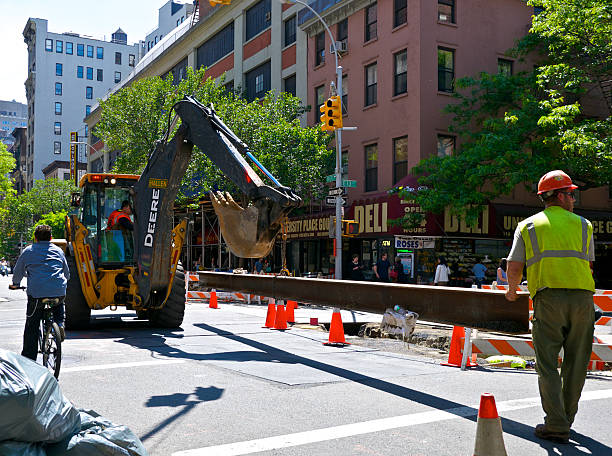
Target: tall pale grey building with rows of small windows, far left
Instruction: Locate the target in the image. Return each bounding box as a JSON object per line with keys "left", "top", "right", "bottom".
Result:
{"left": 23, "top": 18, "right": 139, "bottom": 190}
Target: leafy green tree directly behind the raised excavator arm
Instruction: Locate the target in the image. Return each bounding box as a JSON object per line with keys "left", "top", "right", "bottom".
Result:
{"left": 95, "top": 68, "right": 334, "bottom": 205}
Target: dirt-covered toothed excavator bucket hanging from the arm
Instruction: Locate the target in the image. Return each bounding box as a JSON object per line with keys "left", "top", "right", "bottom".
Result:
{"left": 210, "top": 192, "right": 291, "bottom": 258}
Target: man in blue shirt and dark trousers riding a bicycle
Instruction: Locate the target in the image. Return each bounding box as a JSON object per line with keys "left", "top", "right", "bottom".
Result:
{"left": 9, "top": 225, "right": 70, "bottom": 361}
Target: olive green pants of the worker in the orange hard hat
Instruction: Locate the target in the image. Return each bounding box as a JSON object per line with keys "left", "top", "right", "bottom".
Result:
{"left": 532, "top": 288, "right": 595, "bottom": 432}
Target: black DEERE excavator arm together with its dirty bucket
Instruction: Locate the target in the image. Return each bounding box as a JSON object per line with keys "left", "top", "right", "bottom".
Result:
{"left": 133, "top": 97, "right": 302, "bottom": 303}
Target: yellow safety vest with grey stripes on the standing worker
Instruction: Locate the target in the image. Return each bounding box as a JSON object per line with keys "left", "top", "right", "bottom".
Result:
{"left": 519, "top": 206, "right": 595, "bottom": 298}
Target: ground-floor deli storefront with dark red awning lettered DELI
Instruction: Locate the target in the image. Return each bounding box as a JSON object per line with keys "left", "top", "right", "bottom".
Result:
{"left": 287, "top": 195, "right": 612, "bottom": 288}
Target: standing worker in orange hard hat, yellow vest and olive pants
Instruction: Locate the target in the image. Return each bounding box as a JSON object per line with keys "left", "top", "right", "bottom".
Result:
{"left": 506, "top": 170, "right": 595, "bottom": 443}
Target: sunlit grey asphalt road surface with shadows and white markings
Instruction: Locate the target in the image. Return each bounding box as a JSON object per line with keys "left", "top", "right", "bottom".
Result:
{"left": 0, "top": 277, "right": 612, "bottom": 456}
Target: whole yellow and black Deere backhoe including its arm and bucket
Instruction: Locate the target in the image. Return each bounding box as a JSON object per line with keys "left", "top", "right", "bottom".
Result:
{"left": 66, "top": 98, "right": 301, "bottom": 329}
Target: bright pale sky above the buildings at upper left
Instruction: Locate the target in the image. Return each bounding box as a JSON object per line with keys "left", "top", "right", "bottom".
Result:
{"left": 0, "top": 0, "right": 167, "bottom": 103}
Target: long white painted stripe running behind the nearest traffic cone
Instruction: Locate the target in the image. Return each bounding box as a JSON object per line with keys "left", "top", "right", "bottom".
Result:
{"left": 172, "top": 389, "right": 612, "bottom": 456}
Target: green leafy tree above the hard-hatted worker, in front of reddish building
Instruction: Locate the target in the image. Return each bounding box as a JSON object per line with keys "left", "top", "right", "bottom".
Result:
{"left": 395, "top": 0, "right": 612, "bottom": 226}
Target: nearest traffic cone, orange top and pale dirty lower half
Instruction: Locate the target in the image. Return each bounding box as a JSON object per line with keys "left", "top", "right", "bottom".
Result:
{"left": 474, "top": 393, "right": 508, "bottom": 456}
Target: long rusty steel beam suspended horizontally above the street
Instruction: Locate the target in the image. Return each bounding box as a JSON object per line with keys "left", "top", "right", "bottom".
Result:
{"left": 199, "top": 272, "right": 529, "bottom": 334}
